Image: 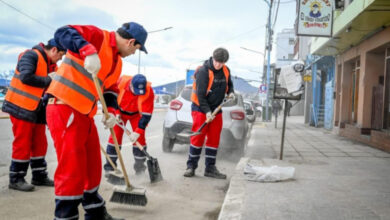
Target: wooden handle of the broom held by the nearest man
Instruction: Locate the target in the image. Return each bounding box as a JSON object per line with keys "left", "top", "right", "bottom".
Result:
{"left": 92, "top": 74, "right": 132, "bottom": 188}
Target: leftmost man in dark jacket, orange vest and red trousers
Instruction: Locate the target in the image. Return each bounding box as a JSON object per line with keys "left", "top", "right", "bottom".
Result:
{"left": 2, "top": 39, "right": 65, "bottom": 191}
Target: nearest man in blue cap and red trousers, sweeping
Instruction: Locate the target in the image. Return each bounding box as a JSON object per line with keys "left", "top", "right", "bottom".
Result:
{"left": 47, "top": 22, "right": 147, "bottom": 219}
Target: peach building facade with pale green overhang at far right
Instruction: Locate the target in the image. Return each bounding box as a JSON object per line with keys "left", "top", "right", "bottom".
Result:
{"left": 311, "top": 0, "right": 390, "bottom": 151}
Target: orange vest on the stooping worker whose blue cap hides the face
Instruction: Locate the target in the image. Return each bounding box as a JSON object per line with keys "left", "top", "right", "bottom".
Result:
{"left": 118, "top": 76, "right": 152, "bottom": 114}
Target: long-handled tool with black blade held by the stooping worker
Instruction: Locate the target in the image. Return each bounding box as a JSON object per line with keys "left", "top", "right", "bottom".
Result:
{"left": 116, "top": 121, "right": 163, "bottom": 183}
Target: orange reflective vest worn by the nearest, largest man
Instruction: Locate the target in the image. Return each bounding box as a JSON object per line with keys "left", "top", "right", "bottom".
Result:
{"left": 47, "top": 31, "right": 122, "bottom": 117}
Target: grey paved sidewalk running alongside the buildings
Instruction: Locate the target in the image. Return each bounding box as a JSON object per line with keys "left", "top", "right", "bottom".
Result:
{"left": 219, "top": 117, "right": 390, "bottom": 220}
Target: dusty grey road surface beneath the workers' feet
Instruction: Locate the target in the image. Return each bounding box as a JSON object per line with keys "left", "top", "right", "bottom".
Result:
{"left": 0, "top": 109, "right": 244, "bottom": 219}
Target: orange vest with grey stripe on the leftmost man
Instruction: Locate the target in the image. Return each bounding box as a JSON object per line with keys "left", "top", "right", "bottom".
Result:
{"left": 5, "top": 49, "right": 48, "bottom": 111}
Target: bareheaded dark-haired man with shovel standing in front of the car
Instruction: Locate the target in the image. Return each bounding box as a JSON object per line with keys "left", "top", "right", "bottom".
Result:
{"left": 184, "top": 48, "right": 235, "bottom": 179}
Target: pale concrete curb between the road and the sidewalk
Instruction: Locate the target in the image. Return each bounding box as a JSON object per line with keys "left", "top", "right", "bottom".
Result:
{"left": 218, "top": 157, "right": 250, "bottom": 220}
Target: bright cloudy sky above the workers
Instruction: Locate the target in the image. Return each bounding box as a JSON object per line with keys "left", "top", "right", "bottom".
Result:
{"left": 0, "top": 0, "right": 296, "bottom": 86}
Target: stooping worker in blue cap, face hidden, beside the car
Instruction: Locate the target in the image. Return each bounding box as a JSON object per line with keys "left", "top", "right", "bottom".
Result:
{"left": 104, "top": 74, "right": 154, "bottom": 175}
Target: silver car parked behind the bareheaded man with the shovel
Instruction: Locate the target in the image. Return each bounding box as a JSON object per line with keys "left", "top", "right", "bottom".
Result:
{"left": 162, "top": 86, "right": 249, "bottom": 153}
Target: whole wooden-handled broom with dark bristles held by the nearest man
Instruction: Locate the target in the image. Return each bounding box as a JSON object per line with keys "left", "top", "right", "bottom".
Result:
{"left": 91, "top": 74, "right": 148, "bottom": 206}
